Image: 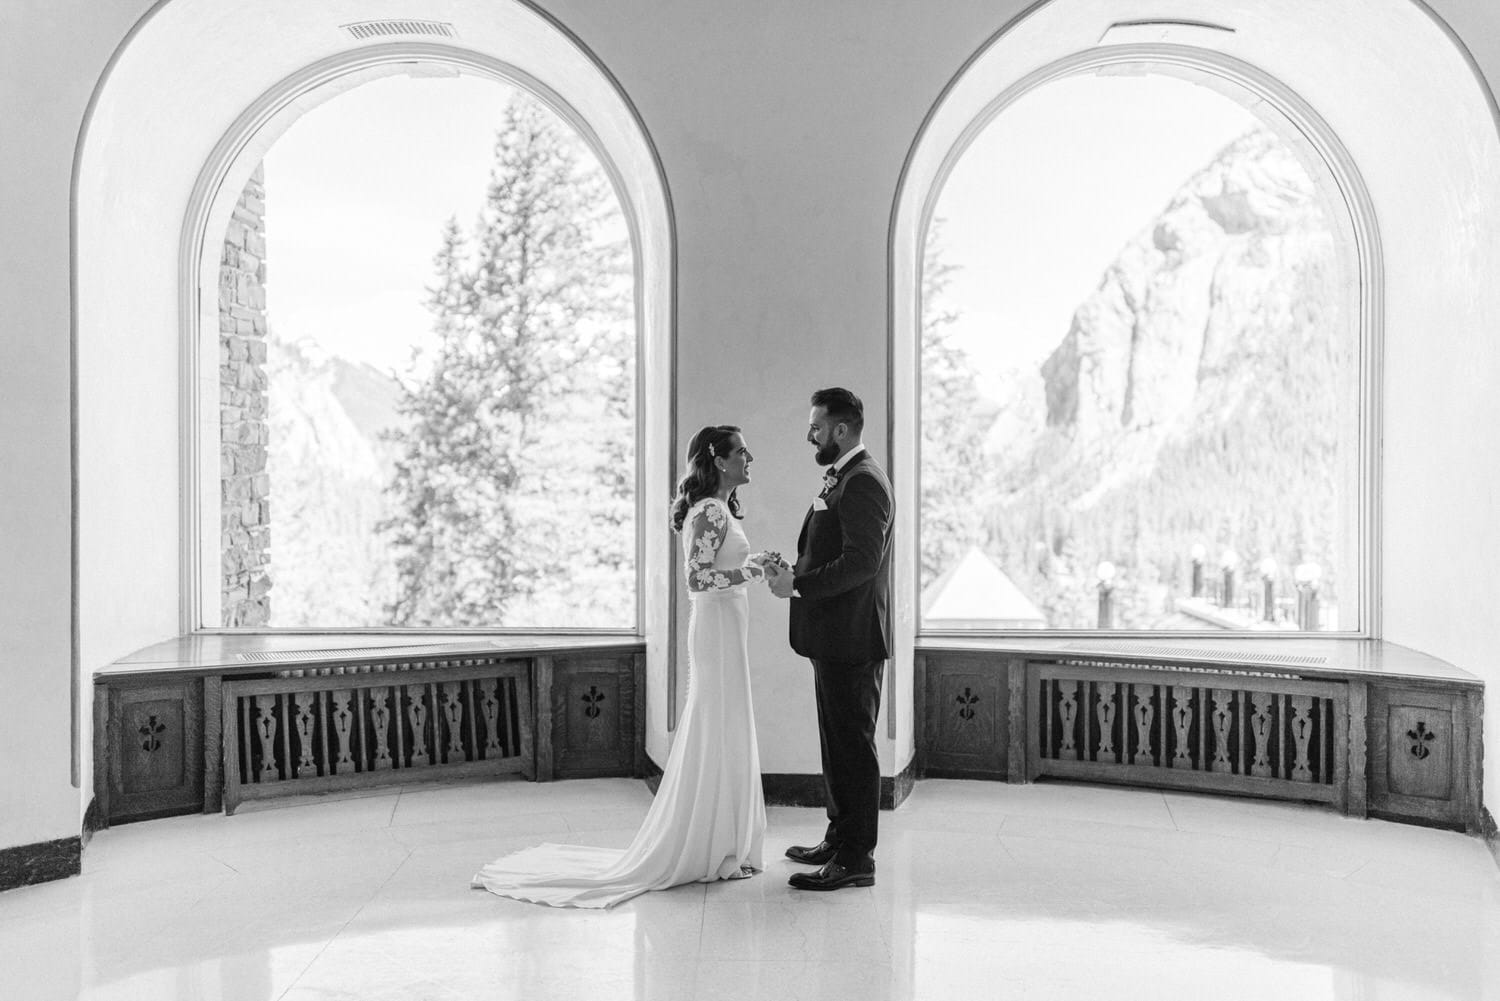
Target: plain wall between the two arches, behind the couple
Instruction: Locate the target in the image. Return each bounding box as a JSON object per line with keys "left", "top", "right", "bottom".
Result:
{"left": 588, "top": 0, "right": 1005, "bottom": 774}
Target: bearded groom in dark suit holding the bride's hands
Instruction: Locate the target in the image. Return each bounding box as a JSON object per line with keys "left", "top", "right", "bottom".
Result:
{"left": 767, "top": 389, "right": 893, "bottom": 890}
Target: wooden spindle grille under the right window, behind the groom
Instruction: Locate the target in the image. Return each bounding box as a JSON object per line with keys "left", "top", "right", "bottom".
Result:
{"left": 1026, "top": 663, "right": 1349, "bottom": 807}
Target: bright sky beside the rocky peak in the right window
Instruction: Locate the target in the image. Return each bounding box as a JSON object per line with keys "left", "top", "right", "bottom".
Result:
{"left": 936, "top": 77, "right": 1256, "bottom": 387}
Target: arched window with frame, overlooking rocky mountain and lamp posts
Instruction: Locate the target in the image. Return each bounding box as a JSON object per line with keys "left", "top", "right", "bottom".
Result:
{"left": 914, "top": 47, "right": 1379, "bottom": 633}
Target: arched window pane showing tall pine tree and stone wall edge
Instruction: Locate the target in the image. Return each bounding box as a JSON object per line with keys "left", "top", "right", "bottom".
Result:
{"left": 211, "top": 72, "right": 638, "bottom": 629}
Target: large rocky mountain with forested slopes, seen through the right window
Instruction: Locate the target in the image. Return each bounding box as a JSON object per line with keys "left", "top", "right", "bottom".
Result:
{"left": 989, "top": 129, "right": 1358, "bottom": 627}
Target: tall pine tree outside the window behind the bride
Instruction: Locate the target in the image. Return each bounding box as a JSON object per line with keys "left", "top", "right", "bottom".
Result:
{"left": 380, "top": 95, "right": 635, "bottom": 626}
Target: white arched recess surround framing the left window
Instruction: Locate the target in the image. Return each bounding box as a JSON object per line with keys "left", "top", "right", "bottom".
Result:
{"left": 74, "top": 0, "right": 677, "bottom": 798}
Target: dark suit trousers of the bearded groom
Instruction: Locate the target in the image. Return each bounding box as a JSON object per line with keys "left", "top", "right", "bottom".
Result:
{"left": 813, "top": 660, "right": 885, "bottom": 870}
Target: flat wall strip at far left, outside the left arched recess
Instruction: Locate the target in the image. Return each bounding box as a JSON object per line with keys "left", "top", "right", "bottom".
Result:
{"left": 0, "top": 0, "right": 159, "bottom": 848}
